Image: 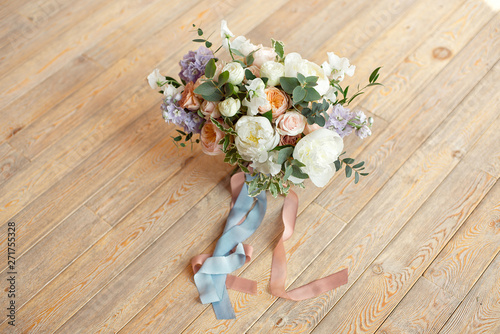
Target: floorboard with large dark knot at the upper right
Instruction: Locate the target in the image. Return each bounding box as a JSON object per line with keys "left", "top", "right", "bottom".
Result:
{"left": 361, "top": 1, "right": 495, "bottom": 121}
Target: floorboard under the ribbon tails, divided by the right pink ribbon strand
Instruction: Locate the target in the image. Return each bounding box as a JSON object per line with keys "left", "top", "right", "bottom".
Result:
{"left": 180, "top": 203, "right": 345, "bottom": 333}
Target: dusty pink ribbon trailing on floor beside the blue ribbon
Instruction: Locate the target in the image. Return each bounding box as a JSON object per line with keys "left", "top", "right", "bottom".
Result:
{"left": 191, "top": 173, "right": 348, "bottom": 301}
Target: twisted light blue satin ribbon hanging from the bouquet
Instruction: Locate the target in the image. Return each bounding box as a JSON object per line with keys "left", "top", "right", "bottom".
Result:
{"left": 194, "top": 174, "right": 267, "bottom": 319}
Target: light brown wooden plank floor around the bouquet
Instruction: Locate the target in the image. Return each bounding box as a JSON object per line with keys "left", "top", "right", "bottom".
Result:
{"left": 0, "top": 0, "right": 500, "bottom": 334}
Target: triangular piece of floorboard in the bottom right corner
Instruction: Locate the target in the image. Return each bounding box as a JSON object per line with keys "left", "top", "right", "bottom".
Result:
{"left": 439, "top": 254, "right": 500, "bottom": 334}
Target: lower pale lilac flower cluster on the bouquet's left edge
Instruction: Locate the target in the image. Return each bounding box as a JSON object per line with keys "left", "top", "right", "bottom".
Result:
{"left": 161, "top": 94, "right": 203, "bottom": 133}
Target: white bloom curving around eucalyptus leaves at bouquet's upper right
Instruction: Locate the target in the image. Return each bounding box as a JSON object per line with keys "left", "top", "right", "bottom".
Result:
{"left": 285, "top": 52, "right": 330, "bottom": 96}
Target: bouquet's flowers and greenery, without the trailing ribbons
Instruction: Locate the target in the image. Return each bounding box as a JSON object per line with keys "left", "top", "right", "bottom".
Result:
{"left": 148, "top": 21, "right": 380, "bottom": 197}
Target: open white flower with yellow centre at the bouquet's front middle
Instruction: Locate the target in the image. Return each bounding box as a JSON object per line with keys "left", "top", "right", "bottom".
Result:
{"left": 235, "top": 116, "right": 280, "bottom": 163}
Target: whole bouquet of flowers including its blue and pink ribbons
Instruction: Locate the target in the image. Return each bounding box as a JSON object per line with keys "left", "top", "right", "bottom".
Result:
{"left": 148, "top": 21, "right": 380, "bottom": 319}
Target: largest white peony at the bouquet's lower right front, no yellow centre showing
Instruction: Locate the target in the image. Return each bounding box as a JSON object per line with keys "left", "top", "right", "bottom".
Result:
{"left": 292, "top": 128, "right": 344, "bottom": 187}
